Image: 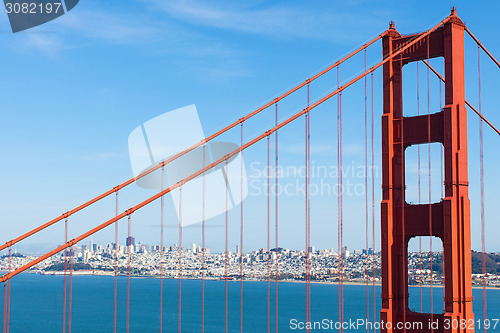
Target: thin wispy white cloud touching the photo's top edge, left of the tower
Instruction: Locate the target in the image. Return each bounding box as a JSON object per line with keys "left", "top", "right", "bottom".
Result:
{"left": 143, "top": 0, "right": 385, "bottom": 41}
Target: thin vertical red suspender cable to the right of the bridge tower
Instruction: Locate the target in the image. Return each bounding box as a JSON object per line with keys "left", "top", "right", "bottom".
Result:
{"left": 477, "top": 46, "right": 488, "bottom": 333}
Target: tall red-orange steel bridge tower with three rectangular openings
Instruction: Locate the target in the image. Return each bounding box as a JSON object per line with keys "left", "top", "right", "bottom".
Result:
{"left": 381, "top": 10, "right": 474, "bottom": 332}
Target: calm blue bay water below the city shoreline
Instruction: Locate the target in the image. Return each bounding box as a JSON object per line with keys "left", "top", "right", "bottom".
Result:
{"left": 0, "top": 274, "right": 500, "bottom": 333}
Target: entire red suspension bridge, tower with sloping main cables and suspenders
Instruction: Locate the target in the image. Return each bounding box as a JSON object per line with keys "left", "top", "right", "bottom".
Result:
{"left": 0, "top": 9, "right": 500, "bottom": 332}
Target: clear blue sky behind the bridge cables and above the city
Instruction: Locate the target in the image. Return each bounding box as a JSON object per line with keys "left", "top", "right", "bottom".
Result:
{"left": 0, "top": 0, "right": 500, "bottom": 252}
